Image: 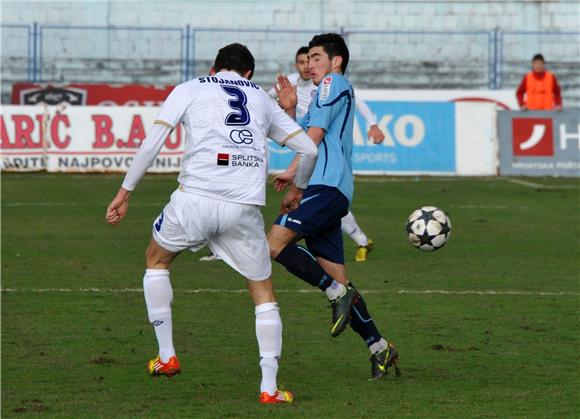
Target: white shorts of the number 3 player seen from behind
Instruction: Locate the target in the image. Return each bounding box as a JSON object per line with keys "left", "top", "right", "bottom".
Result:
{"left": 153, "top": 189, "right": 272, "bottom": 281}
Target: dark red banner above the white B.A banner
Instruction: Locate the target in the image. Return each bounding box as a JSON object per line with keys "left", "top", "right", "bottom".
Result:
{"left": 11, "top": 83, "right": 173, "bottom": 106}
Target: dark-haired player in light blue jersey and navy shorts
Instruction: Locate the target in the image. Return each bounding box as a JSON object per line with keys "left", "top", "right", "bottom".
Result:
{"left": 268, "top": 34, "right": 398, "bottom": 379}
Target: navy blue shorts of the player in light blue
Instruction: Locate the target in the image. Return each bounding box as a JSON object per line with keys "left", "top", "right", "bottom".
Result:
{"left": 274, "top": 185, "right": 348, "bottom": 265}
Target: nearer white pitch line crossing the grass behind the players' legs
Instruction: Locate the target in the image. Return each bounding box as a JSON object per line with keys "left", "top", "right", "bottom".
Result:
{"left": 0, "top": 288, "right": 580, "bottom": 297}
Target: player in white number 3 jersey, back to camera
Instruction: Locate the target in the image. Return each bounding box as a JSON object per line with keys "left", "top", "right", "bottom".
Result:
{"left": 106, "top": 44, "right": 318, "bottom": 403}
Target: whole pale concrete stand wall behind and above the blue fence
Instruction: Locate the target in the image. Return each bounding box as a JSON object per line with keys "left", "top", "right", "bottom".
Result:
{"left": 0, "top": 0, "right": 580, "bottom": 106}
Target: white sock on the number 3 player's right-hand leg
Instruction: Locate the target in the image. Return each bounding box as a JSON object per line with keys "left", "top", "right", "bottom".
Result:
{"left": 256, "top": 303, "right": 282, "bottom": 395}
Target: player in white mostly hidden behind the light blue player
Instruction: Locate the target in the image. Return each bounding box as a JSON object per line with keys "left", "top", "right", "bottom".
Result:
{"left": 270, "top": 47, "right": 385, "bottom": 262}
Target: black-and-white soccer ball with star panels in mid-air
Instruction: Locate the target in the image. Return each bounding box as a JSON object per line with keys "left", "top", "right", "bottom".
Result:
{"left": 405, "top": 207, "right": 451, "bottom": 252}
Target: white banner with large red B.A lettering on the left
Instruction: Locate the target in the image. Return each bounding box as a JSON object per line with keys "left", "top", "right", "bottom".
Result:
{"left": 0, "top": 106, "right": 183, "bottom": 172}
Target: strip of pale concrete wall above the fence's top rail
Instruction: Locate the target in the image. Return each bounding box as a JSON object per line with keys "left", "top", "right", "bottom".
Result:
{"left": 2, "top": 0, "right": 580, "bottom": 31}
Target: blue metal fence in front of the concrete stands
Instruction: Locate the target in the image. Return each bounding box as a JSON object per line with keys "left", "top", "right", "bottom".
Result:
{"left": 0, "top": 23, "right": 580, "bottom": 106}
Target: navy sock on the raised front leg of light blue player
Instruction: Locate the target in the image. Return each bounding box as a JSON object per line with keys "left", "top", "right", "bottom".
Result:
{"left": 275, "top": 244, "right": 333, "bottom": 291}
